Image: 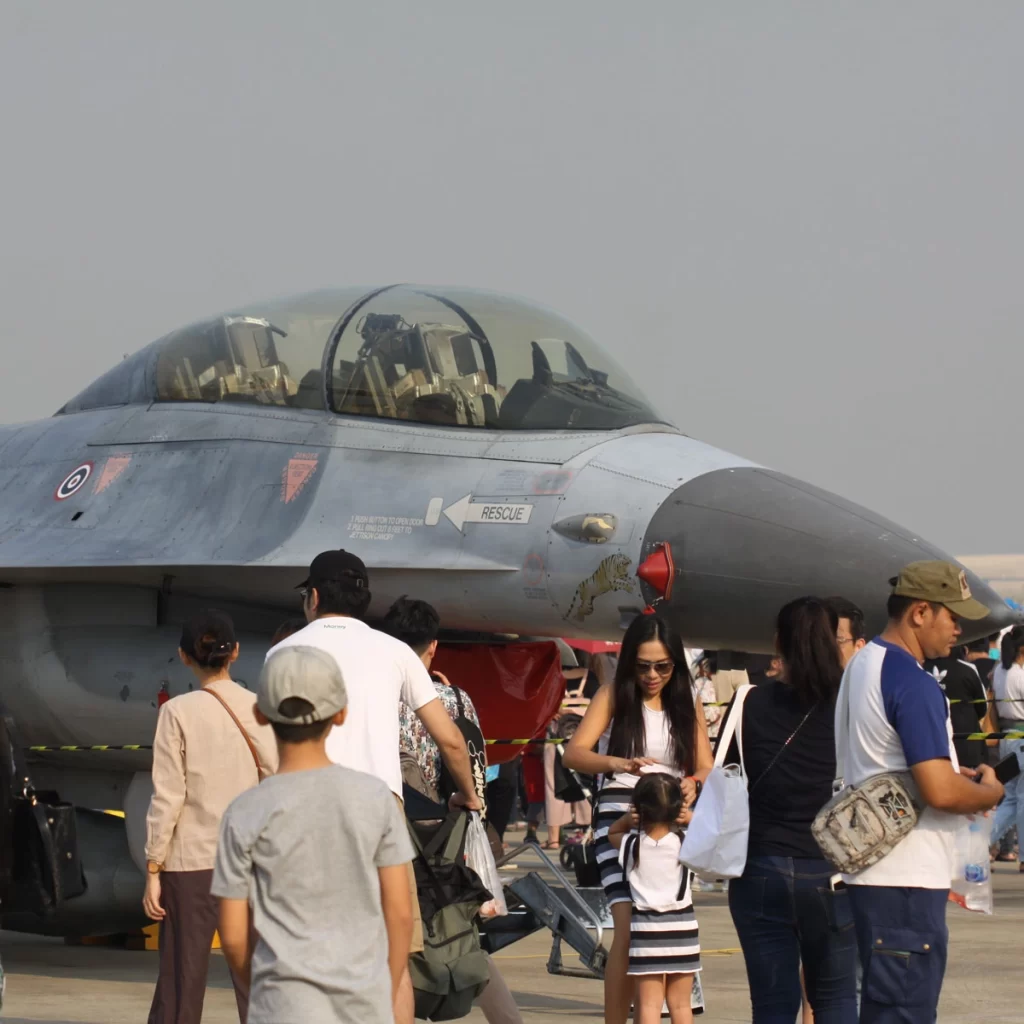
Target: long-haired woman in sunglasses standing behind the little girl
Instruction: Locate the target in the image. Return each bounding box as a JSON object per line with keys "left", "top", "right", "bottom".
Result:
{"left": 563, "top": 614, "right": 713, "bottom": 1024}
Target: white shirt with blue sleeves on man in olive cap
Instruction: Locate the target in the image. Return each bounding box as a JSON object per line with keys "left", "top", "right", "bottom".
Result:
{"left": 836, "top": 639, "right": 961, "bottom": 889}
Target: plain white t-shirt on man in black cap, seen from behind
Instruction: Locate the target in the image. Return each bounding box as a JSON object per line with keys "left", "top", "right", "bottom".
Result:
{"left": 267, "top": 615, "right": 437, "bottom": 797}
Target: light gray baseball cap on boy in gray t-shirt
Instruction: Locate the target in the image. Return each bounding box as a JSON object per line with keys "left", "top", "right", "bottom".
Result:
{"left": 256, "top": 645, "right": 348, "bottom": 725}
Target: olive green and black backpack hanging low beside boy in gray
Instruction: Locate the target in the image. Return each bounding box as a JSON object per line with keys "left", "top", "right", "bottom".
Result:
{"left": 409, "top": 805, "right": 492, "bottom": 1021}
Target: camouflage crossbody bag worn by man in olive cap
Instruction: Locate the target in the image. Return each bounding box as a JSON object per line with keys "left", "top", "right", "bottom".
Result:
{"left": 811, "top": 679, "right": 924, "bottom": 874}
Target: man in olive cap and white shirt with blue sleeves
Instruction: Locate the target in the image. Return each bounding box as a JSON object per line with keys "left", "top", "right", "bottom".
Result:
{"left": 835, "top": 561, "right": 1002, "bottom": 1024}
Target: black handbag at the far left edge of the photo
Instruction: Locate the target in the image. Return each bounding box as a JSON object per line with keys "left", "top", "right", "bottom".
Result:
{"left": 0, "top": 726, "right": 86, "bottom": 914}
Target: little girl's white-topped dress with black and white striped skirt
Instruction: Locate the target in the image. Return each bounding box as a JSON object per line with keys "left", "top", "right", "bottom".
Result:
{"left": 618, "top": 829, "right": 700, "bottom": 975}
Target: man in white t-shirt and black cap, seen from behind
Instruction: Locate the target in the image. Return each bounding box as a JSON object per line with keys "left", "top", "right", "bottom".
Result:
{"left": 267, "top": 551, "right": 481, "bottom": 1024}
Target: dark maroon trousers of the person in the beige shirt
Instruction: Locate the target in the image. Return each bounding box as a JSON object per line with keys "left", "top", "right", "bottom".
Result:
{"left": 150, "top": 870, "right": 249, "bottom": 1024}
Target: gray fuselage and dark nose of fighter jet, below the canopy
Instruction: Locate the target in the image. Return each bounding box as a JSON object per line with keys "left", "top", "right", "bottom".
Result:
{"left": 0, "top": 282, "right": 1013, "bottom": 937}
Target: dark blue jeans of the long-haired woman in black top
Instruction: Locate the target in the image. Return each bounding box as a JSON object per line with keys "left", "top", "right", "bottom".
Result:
{"left": 729, "top": 857, "right": 857, "bottom": 1024}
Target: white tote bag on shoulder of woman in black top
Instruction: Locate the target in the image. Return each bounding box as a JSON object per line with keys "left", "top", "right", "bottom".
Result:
{"left": 679, "top": 683, "right": 754, "bottom": 879}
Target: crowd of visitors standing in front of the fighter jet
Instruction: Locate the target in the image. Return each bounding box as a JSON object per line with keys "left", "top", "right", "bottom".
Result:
{"left": 144, "top": 551, "right": 1011, "bottom": 1024}
